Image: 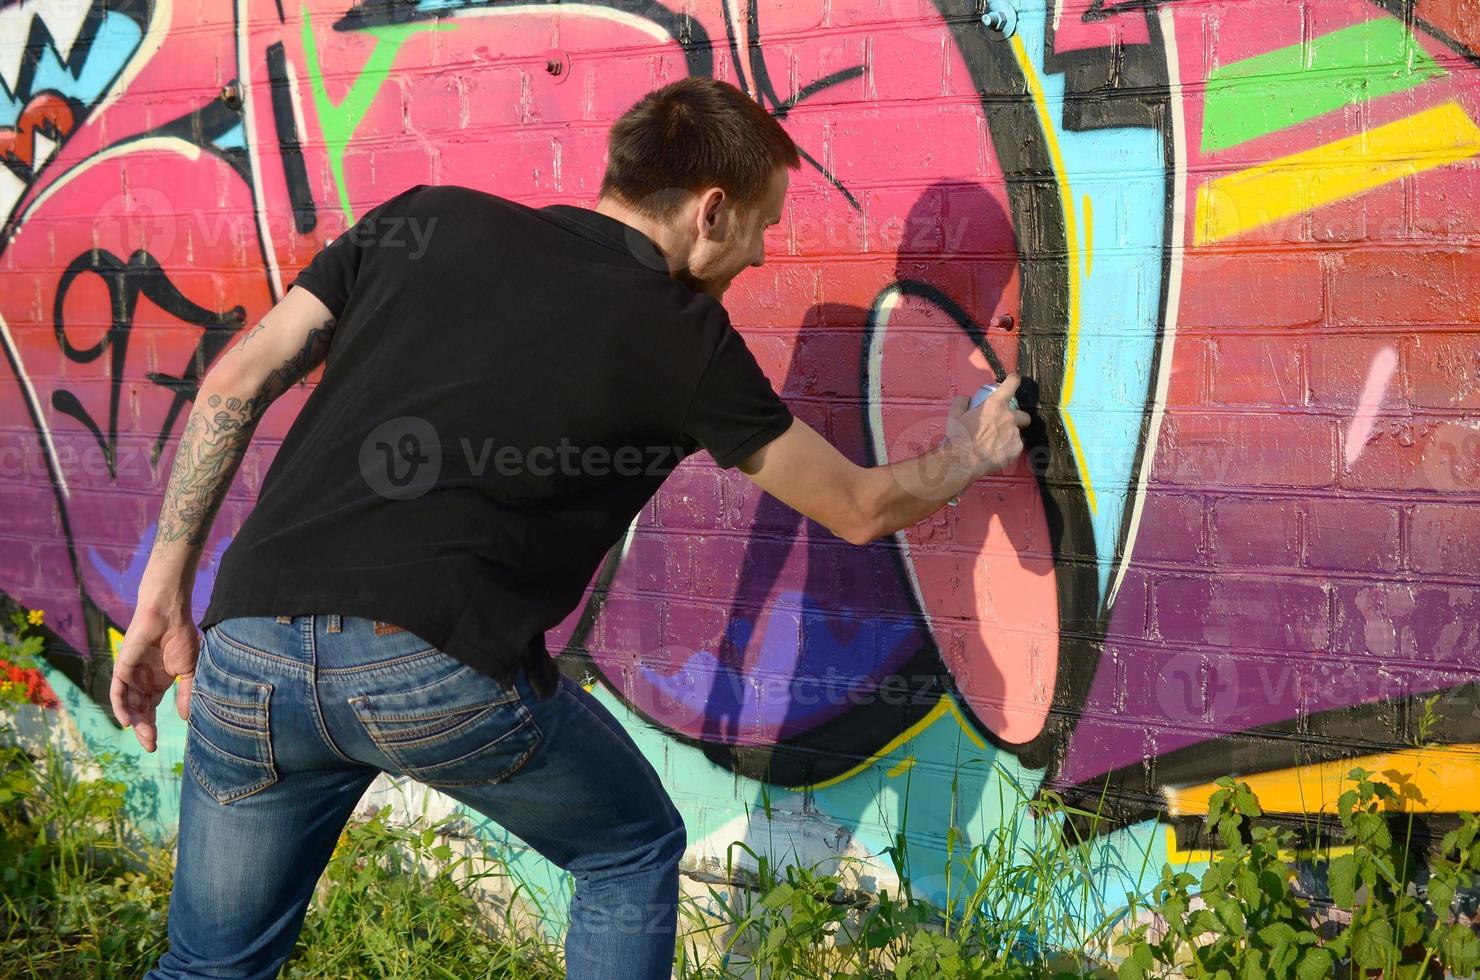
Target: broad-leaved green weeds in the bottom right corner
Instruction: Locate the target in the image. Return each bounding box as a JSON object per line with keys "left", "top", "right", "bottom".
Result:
{"left": 1120, "top": 699, "right": 1480, "bottom": 980}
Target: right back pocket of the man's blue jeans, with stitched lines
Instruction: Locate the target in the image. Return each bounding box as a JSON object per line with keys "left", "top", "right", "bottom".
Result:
{"left": 349, "top": 665, "right": 542, "bottom": 786}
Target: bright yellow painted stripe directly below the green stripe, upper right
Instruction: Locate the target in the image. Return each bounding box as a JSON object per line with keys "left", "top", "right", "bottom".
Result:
{"left": 1196, "top": 102, "right": 1480, "bottom": 246}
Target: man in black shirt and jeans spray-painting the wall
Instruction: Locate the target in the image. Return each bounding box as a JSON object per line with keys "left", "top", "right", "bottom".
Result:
{"left": 112, "top": 78, "right": 1027, "bottom": 980}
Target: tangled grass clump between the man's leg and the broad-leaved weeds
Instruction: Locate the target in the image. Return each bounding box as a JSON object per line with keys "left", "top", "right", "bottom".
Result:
{"left": 678, "top": 754, "right": 1120, "bottom": 980}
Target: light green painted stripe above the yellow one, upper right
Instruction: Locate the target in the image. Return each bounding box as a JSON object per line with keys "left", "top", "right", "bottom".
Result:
{"left": 1202, "top": 16, "right": 1446, "bottom": 152}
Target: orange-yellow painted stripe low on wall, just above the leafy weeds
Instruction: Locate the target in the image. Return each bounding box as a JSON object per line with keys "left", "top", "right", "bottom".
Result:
{"left": 1165, "top": 745, "right": 1480, "bottom": 816}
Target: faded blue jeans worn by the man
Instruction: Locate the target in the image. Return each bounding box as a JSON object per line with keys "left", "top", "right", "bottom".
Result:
{"left": 145, "top": 614, "right": 687, "bottom": 980}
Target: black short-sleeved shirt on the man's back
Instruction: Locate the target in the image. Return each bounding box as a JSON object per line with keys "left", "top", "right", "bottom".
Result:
{"left": 200, "top": 184, "right": 792, "bottom": 690}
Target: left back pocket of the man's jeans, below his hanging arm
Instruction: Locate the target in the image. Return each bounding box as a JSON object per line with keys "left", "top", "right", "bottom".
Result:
{"left": 185, "top": 628, "right": 278, "bottom": 804}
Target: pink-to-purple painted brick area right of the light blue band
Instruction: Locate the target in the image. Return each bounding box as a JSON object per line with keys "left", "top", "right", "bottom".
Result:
{"left": 1058, "top": 3, "right": 1480, "bottom": 786}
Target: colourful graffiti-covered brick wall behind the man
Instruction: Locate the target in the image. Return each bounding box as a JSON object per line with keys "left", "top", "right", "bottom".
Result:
{"left": 0, "top": 0, "right": 1480, "bottom": 929}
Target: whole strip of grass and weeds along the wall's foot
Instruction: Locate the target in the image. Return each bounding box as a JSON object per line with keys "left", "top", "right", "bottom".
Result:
{"left": 0, "top": 609, "right": 1480, "bottom": 980}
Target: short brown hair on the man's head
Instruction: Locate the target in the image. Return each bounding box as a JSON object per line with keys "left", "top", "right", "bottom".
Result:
{"left": 601, "top": 75, "right": 801, "bottom": 221}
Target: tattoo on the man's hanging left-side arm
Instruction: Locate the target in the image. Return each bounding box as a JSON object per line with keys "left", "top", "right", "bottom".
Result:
{"left": 154, "top": 320, "right": 334, "bottom": 552}
